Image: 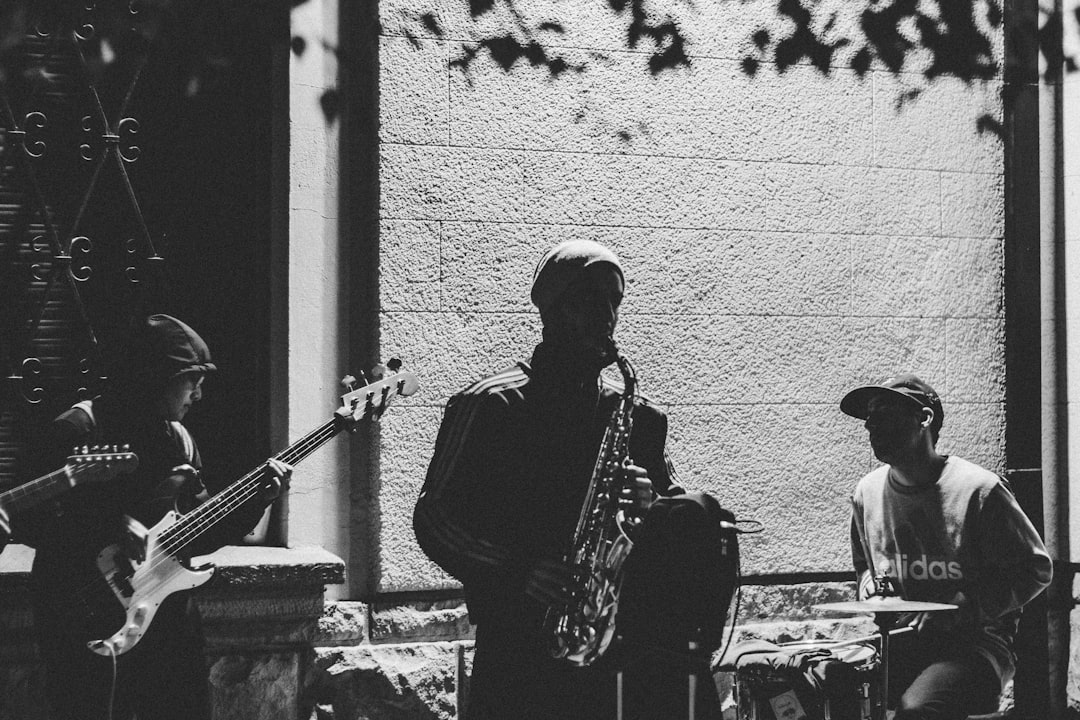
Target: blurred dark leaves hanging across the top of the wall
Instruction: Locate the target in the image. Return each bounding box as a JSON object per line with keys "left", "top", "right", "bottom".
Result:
{"left": 380, "top": 0, "right": 1080, "bottom": 142}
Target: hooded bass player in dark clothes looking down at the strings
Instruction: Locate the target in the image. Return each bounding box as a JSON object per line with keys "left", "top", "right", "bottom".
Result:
{"left": 27, "top": 315, "right": 292, "bottom": 720}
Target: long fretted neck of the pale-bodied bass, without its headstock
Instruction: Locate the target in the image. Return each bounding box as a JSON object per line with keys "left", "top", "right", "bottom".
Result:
{"left": 161, "top": 419, "right": 342, "bottom": 555}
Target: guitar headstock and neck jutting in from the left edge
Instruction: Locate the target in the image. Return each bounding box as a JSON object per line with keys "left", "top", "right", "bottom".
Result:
{"left": 0, "top": 446, "right": 138, "bottom": 539}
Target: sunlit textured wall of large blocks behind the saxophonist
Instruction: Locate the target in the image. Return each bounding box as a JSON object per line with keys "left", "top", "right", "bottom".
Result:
{"left": 379, "top": 0, "right": 1004, "bottom": 590}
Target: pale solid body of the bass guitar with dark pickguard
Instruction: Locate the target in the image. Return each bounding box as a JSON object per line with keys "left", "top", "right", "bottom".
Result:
{"left": 86, "top": 512, "right": 214, "bottom": 656}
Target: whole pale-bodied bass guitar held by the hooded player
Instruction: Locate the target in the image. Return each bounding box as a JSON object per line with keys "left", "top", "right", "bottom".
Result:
{"left": 86, "top": 361, "right": 419, "bottom": 656}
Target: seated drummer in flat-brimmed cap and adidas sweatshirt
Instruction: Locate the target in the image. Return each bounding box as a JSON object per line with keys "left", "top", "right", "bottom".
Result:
{"left": 840, "top": 375, "right": 1052, "bottom": 720}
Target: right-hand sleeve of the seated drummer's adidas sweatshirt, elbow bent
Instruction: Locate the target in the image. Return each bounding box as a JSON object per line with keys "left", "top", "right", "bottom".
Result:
{"left": 977, "top": 481, "right": 1053, "bottom": 621}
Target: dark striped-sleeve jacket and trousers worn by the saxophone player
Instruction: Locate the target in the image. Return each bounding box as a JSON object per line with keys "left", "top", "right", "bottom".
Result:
{"left": 414, "top": 344, "right": 691, "bottom": 720}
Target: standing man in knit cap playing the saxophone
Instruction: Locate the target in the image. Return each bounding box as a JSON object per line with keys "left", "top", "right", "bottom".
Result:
{"left": 414, "top": 241, "right": 718, "bottom": 720}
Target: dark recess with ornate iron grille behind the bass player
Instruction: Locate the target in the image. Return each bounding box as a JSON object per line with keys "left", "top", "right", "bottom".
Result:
{"left": 0, "top": 0, "right": 278, "bottom": 490}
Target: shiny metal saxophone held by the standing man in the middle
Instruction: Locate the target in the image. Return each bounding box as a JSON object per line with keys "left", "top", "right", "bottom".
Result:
{"left": 543, "top": 340, "right": 638, "bottom": 667}
